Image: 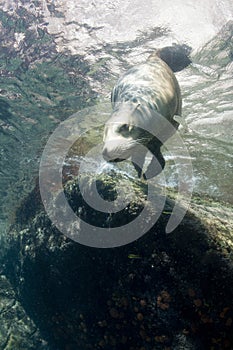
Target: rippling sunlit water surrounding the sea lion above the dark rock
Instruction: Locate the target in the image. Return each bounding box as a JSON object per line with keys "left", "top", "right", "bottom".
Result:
{"left": 0, "top": 0, "right": 233, "bottom": 238}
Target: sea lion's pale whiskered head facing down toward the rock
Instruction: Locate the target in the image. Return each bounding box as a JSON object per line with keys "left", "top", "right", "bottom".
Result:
{"left": 102, "top": 103, "right": 144, "bottom": 162}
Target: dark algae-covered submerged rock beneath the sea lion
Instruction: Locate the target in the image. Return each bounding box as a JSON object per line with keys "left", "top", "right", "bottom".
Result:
{"left": 0, "top": 173, "right": 233, "bottom": 350}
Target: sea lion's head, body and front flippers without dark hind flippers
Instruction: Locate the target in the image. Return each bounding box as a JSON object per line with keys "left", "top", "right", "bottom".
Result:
{"left": 102, "top": 50, "right": 187, "bottom": 179}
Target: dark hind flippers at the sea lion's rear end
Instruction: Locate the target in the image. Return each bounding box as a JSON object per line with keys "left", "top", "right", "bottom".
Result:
{"left": 148, "top": 45, "right": 192, "bottom": 72}
